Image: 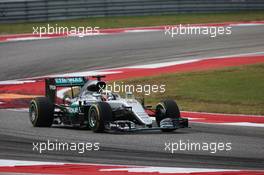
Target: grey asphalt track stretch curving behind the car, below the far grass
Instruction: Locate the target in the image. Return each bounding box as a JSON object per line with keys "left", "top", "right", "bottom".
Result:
{"left": 0, "top": 26, "right": 264, "bottom": 81}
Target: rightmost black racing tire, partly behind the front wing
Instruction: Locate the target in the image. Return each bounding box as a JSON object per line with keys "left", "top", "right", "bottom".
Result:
{"left": 156, "top": 100, "right": 181, "bottom": 132}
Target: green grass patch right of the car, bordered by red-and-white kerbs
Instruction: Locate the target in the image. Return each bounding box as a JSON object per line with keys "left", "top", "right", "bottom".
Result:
{"left": 119, "top": 64, "right": 264, "bottom": 115}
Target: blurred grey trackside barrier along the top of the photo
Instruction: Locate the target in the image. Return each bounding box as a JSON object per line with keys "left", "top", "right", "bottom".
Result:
{"left": 0, "top": 0, "right": 264, "bottom": 23}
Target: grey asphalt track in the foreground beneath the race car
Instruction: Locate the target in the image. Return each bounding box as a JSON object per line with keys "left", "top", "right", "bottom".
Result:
{"left": 0, "top": 110, "right": 264, "bottom": 169}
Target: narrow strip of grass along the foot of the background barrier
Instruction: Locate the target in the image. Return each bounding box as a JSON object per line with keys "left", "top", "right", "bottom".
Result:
{"left": 0, "top": 11, "right": 264, "bottom": 34}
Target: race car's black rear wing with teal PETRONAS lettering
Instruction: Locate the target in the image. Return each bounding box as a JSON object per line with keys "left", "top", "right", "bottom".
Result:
{"left": 45, "top": 77, "right": 88, "bottom": 103}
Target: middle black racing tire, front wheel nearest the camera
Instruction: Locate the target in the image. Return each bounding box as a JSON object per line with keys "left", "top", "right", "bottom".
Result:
{"left": 88, "top": 102, "right": 113, "bottom": 132}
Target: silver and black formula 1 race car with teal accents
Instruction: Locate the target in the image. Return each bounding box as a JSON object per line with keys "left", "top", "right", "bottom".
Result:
{"left": 29, "top": 76, "right": 188, "bottom": 132}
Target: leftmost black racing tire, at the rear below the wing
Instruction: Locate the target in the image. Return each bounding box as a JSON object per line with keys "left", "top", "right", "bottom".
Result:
{"left": 29, "top": 97, "right": 54, "bottom": 127}
